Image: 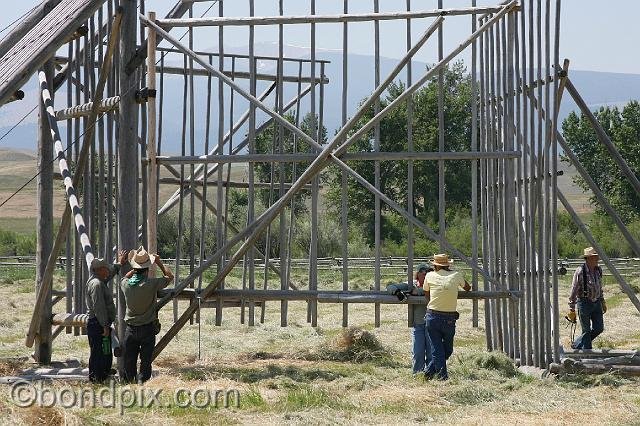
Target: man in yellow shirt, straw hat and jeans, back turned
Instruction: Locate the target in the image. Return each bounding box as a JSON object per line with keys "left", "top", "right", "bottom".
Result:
{"left": 424, "top": 254, "right": 471, "bottom": 380}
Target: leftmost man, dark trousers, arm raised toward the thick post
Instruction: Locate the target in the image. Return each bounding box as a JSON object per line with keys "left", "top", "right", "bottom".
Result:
{"left": 85, "top": 250, "right": 127, "bottom": 383}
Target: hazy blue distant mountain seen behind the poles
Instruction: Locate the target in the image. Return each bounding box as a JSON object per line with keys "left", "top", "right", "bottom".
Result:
{"left": 0, "top": 43, "right": 640, "bottom": 154}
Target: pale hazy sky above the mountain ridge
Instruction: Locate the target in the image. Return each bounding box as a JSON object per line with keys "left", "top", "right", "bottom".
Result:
{"left": 0, "top": 0, "right": 640, "bottom": 74}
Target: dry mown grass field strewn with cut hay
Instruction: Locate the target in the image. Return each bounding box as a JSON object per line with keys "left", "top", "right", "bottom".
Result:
{"left": 0, "top": 269, "right": 640, "bottom": 425}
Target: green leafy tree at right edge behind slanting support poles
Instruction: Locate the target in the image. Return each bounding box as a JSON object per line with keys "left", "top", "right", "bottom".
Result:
{"left": 562, "top": 101, "right": 640, "bottom": 221}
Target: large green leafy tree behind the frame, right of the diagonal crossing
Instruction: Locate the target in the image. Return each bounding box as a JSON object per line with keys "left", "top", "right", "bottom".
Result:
{"left": 328, "top": 62, "right": 471, "bottom": 244}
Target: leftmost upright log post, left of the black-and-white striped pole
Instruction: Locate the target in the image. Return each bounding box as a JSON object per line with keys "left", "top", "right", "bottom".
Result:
{"left": 35, "top": 61, "right": 54, "bottom": 364}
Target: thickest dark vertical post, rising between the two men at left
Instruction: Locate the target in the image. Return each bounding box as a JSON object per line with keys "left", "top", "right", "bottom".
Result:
{"left": 117, "top": 0, "right": 138, "bottom": 371}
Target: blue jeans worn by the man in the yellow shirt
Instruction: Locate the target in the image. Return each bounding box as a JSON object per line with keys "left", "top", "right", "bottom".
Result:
{"left": 425, "top": 312, "right": 456, "bottom": 380}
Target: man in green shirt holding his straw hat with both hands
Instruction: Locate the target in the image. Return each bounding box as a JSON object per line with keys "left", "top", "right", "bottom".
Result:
{"left": 120, "top": 246, "right": 173, "bottom": 382}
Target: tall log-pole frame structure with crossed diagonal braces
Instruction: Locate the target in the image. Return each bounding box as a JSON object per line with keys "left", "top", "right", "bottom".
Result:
{"left": 0, "top": 0, "right": 640, "bottom": 367}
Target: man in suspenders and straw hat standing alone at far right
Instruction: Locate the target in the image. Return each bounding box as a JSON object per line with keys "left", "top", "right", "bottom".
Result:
{"left": 567, "top": 247, "right": 607, "bottom": 349}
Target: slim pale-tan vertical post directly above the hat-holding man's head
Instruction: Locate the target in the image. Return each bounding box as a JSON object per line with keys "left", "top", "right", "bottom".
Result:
{"left": 147, "top": 12, "right": 158, "bottom": 276}
